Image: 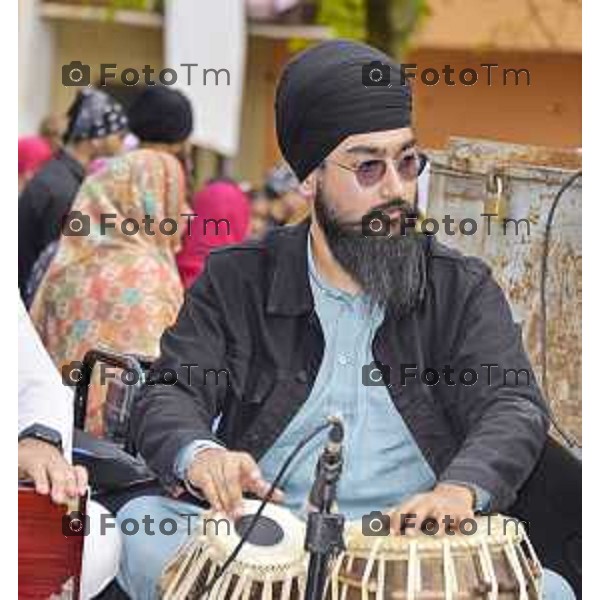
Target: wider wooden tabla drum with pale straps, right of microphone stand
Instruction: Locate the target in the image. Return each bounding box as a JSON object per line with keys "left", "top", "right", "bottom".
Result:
{"left": 327, "top": 515, "right": 542, "bottom": 600}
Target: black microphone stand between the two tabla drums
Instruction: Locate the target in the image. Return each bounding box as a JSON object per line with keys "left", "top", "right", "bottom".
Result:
{"left": 304, "top": 423, "right": 345, "bottom": 600}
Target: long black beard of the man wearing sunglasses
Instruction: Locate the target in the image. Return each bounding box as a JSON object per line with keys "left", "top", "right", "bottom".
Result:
{"left": 315, "top": 187, "right": 427, "bottom": 317}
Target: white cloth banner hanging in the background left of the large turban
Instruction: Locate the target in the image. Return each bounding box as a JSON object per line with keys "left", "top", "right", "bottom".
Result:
{"left": 164, "top": 0, "right": 246, "bottom": 157}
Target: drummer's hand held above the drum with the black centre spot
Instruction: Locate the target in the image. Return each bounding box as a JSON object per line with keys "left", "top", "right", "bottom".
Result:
{"left": 187, "top": 448, "right": 283, "bottom": 517}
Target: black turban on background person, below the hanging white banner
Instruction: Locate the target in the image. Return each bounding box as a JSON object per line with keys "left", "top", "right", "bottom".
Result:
{"left": 129, "top": 85, "right": 193, "bottom": 144}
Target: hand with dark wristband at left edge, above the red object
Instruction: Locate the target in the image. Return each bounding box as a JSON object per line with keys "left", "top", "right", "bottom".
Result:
{"left": 19, "top": 438, "right": 88, "bottom": 504}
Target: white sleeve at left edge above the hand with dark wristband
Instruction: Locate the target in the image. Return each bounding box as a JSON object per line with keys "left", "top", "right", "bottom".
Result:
{"left": 18, "top": 300, "right": 73, "bottom": 461}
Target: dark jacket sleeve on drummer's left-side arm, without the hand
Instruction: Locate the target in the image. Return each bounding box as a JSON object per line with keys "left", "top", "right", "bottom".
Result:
{"left": 131, "top": 259, "right": 226, "bottom": 486}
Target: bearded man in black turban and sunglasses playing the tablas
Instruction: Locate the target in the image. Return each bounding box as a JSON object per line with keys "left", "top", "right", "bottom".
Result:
{"left": 119, "top": 41, "right": 570, "bottom": 598}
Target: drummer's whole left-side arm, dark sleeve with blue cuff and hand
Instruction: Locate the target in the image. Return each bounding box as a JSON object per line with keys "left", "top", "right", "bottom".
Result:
{"left": 131, "top": 258, "right": 283, "bottom": 515}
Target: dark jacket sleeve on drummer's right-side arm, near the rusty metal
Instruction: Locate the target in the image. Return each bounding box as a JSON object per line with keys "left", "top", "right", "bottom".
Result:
{"left": 440, "top": 272, "right": 548, "bottom": 509}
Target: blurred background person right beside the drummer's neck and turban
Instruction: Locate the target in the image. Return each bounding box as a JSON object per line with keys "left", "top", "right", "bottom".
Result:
{"left": 265, "top": 163, "right": 309, "bottom": 225}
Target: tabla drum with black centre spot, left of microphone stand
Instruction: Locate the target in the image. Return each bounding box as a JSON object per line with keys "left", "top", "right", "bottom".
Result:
{"left": 160, "top": 500, "right": 308, "bottom": 600}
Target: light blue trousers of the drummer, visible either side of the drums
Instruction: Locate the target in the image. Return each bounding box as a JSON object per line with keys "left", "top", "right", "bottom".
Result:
{"left": 117, "top": 496, "right": 575, "bottom": 600}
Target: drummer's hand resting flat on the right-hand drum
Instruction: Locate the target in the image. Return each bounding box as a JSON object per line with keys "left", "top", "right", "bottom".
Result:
{"left": 388, "top": 483, "right": 475, "bottom": 535}
